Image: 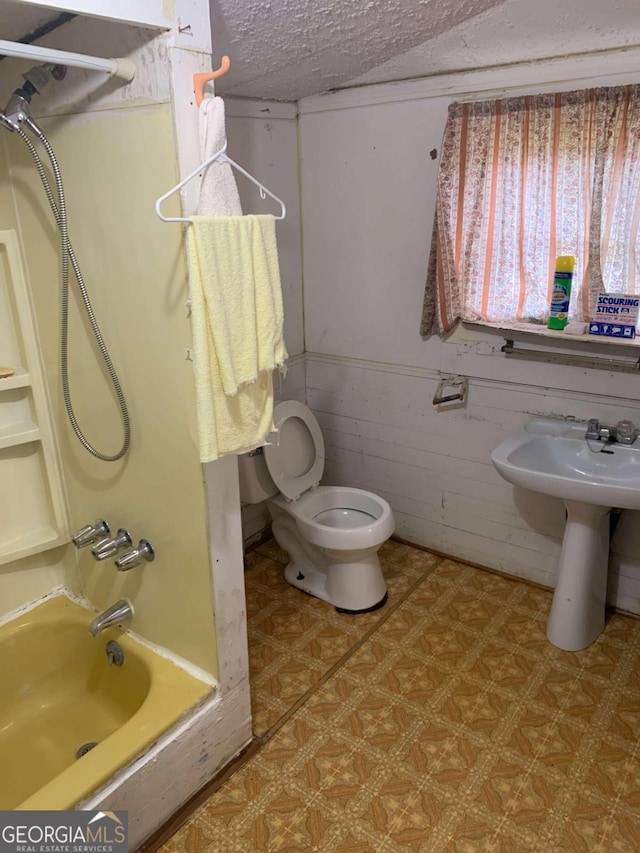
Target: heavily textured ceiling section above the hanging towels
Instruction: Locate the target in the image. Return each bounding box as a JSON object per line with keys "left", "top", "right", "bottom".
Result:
{"left": 211, "top": 0, "right": 503, "bottom": 100}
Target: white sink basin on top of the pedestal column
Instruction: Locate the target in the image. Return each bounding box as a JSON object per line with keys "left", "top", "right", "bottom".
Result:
{"left": 491, "top": 418, "right": 640, "bottom": 509}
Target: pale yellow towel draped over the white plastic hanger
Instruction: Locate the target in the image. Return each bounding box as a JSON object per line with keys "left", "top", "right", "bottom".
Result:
{"left": 187, "top": 216, "right": 287, "bottom": 462}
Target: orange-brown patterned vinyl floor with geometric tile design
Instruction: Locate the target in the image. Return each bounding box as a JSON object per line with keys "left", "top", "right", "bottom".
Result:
{"left": 163, "top": 543, "right": 640, "bottom": 853}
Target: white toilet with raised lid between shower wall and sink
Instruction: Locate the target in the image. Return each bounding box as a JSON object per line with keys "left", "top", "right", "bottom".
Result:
{"left": 238, "top": 400, "right": 395, "bottom": 613}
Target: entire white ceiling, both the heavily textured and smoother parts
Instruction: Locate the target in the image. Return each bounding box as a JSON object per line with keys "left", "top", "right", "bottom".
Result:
{"left": 210, "top": 0, "right": 640, "bottom": 100}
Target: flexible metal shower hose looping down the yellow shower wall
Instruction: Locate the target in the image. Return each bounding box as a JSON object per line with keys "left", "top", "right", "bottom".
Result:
{"left": 18, "top": 129, "right": 131, "bottom": 462}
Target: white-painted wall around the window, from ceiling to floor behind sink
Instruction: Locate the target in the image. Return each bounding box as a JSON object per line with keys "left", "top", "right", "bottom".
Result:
{"left": 299, "top": 50, "right": 640, "bottom": 612}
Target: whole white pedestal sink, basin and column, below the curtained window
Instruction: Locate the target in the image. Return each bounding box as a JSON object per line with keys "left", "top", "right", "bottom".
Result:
{"left": 491, "top": 418, "right": 640, "bottom": 651}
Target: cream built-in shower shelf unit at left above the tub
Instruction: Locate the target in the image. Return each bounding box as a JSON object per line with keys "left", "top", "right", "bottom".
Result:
{"left": 0, "top": 230, "right": 69, "bottom": 565}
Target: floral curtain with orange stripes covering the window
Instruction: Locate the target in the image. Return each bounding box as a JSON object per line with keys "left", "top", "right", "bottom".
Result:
{"left": 421, "top": 85, "right": 640, "bottom": 334}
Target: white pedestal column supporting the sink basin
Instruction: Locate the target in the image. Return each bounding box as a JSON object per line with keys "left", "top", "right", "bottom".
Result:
{"left": 547, "top": 501, "right": 610, "bottom": 652}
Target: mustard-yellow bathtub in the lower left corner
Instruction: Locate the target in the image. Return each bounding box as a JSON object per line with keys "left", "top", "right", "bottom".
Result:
{"left": 0, "top": 596, "right": 213, "bottom": 810}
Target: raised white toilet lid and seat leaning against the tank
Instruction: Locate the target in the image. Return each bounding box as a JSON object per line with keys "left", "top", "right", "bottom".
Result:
{"left": 264, "top": 400, "right": 324, "bottom": 501}
